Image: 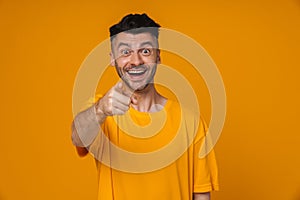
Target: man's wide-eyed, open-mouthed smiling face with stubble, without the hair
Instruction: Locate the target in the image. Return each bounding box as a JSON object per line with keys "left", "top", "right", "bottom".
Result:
{"left": 111, "top": 32, "right": 160, "bottom": 90}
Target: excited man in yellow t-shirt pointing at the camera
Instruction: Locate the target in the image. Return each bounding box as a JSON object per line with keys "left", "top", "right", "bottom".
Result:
{"left": 72, "top": 14, "right": 218, "bottom": 200}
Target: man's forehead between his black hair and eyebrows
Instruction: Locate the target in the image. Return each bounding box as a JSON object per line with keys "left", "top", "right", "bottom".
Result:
{"left": 112, "top": 32, "right": 157, "bottom": 47}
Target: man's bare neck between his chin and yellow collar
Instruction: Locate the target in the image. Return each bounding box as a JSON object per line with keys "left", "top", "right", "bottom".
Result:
{"left": 132, "top": 84, "right": 167, "bottom": 112}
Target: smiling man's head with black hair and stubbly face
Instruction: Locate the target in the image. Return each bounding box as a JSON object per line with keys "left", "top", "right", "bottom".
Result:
{"left": 110, "top": 14, "right": 160, "bottom": 90}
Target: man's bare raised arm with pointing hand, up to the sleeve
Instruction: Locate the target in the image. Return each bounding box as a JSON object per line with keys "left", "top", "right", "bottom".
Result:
{"left": 72, "top": 82, "right": 131, "bottom": 156}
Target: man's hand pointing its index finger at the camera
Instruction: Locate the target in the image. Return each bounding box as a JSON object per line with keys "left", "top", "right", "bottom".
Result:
{"left": 95, "top": 81, "right": 136, "bottom": 117}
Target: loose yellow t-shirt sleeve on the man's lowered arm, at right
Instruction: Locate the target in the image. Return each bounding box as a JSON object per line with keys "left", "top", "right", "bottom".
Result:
{"left": 193, "top": 118, "right": 219, "bottom": 193}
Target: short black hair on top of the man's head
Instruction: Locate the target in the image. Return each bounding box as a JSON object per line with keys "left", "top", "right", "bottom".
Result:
{"left": 109, "top": 13, "right": 160, "bottom": 40}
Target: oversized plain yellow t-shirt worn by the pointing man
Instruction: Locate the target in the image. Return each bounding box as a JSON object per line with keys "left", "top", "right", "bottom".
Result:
{"left": 89, "top": 100, "right": 218, "bottom": 200}
